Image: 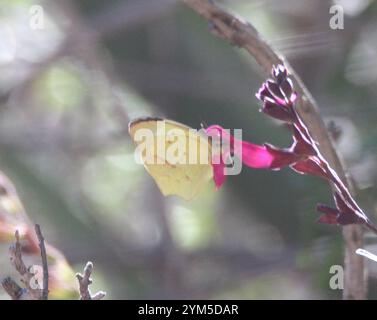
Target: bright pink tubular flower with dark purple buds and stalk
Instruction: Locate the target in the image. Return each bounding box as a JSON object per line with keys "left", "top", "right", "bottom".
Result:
{"left": 206, "top": 65, "right": 377, "bottom": 233}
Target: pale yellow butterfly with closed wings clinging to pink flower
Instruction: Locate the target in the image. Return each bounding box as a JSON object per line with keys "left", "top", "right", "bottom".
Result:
{"left": 129, "top": 118, "right": 213, "bottom": 200}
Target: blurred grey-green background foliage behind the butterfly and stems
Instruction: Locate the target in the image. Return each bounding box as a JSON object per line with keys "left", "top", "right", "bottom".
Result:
{"left": 0, "top": 0, "right": 377, "bottom": 299}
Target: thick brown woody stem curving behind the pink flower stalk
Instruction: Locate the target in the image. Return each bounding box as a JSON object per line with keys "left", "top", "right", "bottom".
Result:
{"left": 183, "top": 0, "right": 366, "bottom": 299}
